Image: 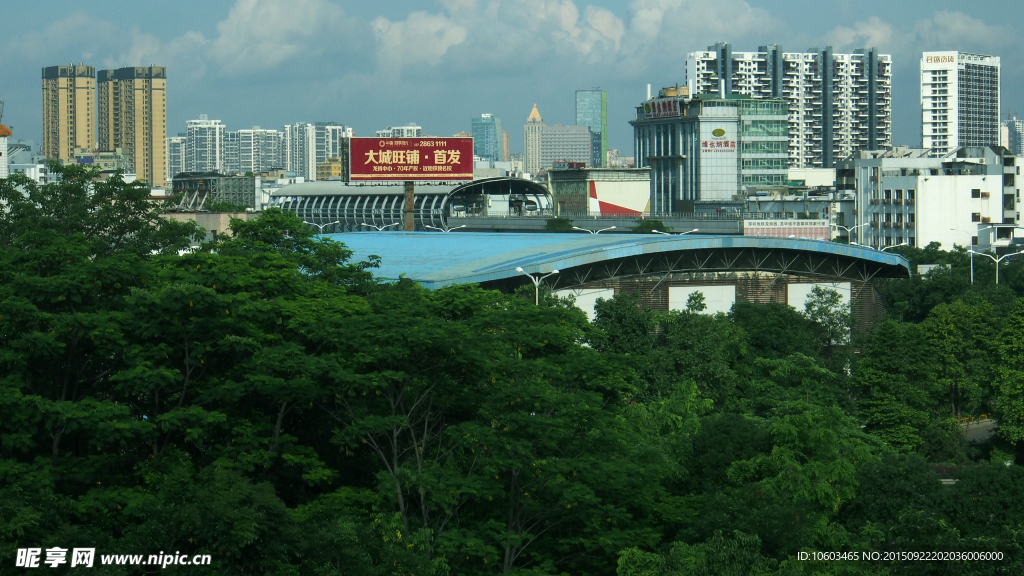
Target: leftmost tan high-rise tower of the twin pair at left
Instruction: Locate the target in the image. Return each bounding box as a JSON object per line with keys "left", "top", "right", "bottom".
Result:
{"left": 41, "top": 64, "right": 95, "bottom": 161}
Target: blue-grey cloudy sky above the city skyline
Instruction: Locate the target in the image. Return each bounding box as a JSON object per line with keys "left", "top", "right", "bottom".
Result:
{"left": 0, "top": 0, "right": 1024, "bottom": 153}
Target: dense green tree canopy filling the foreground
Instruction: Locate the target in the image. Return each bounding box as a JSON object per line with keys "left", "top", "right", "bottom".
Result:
{"left": 0, "top": 167, "right": 1024, "bottom": 576}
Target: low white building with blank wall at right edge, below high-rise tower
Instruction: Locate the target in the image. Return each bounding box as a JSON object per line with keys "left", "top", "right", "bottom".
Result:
{"left": 836, "top": 147, "right": 1024, "bottom": 251}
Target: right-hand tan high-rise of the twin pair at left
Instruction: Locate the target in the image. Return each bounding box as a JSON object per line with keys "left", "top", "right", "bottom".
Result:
{"left": 96, "top": 66, "right": 167, "bottom": 186}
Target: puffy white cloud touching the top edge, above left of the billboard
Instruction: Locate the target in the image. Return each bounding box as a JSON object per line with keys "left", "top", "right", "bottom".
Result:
{"left": 209, "top": 0, "right": 344, "bottom": 73}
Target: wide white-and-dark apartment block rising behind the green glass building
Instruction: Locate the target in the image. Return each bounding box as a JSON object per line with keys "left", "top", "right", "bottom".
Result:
{"left": 686, "top": 42, "right": 892, "bottom": 168}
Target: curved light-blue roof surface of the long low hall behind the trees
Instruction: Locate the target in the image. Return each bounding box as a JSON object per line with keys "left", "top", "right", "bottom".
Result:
{"left": 326, "top": 232, "right": 910, "bottom": 289}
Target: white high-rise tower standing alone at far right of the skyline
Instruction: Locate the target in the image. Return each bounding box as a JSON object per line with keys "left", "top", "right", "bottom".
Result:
{"left": 921, "top": 51, "right": 999, "bottom": 154}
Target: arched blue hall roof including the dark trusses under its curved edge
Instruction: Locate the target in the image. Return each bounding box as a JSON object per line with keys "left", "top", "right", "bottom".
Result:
{"left": 327, "top": 232, "right": 910, "bottom": 289}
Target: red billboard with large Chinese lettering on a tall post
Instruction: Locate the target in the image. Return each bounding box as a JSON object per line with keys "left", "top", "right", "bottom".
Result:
{"left": 348, "top": 138, "right": 473, "bottom": 180}
